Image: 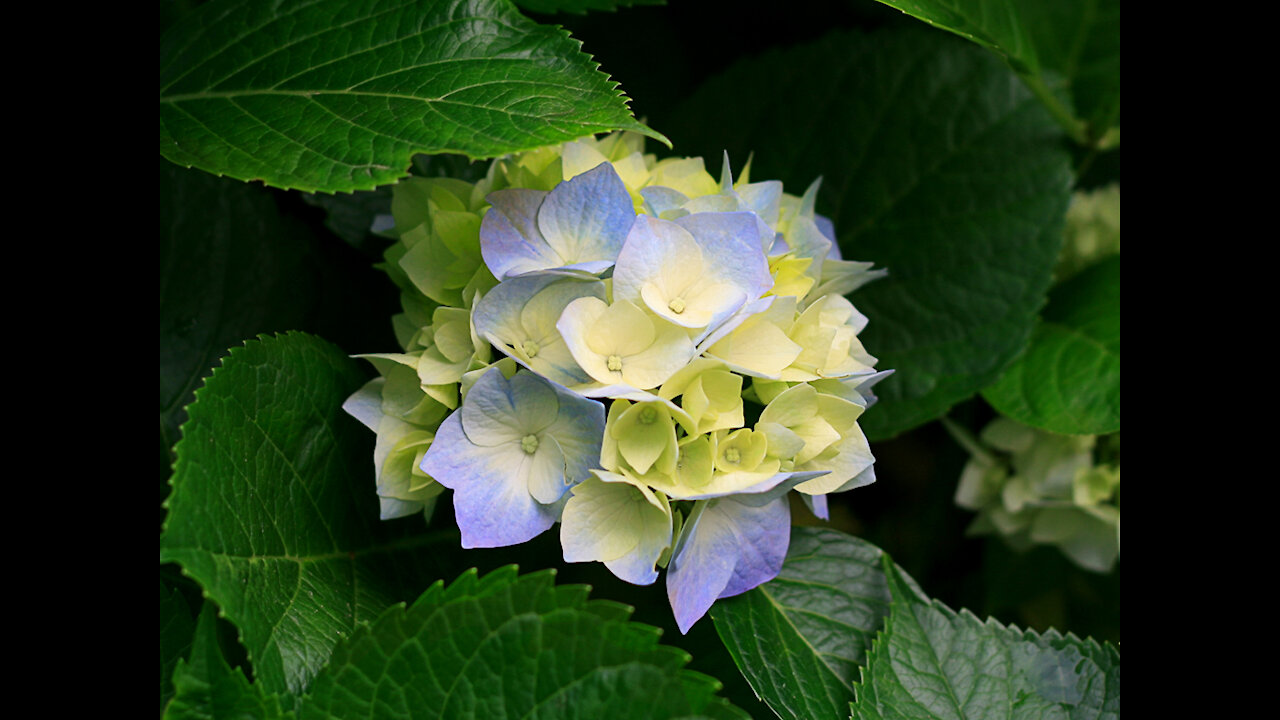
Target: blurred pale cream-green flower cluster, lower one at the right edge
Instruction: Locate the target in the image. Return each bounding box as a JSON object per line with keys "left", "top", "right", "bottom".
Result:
{"left": 952, "top": 418, "right": 1120, "bottom": 573}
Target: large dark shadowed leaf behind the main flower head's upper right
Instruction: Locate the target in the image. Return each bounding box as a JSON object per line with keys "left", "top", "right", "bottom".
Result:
{"left": 669, "top": 26, "right": 1071, "bottom": 441}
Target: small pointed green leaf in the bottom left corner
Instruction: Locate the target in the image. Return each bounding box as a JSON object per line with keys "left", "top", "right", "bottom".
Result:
{"left": 164, "top": 602, "right": 293, "bottom": 720}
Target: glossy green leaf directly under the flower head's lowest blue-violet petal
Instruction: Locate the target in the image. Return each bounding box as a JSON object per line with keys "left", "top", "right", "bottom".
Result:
{"left": 710, "top": 527, "right": 921, "bottom": 720}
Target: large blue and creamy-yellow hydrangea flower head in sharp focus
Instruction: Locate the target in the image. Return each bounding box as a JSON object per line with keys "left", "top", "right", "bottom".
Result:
{"left": 347, "top": 133, "right": 888, "bottom": 632}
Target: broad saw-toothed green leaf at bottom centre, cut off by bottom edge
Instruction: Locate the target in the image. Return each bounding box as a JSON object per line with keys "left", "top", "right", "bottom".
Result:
{"left": 298, "top": 565, "right": 746, "bottom": 720}
